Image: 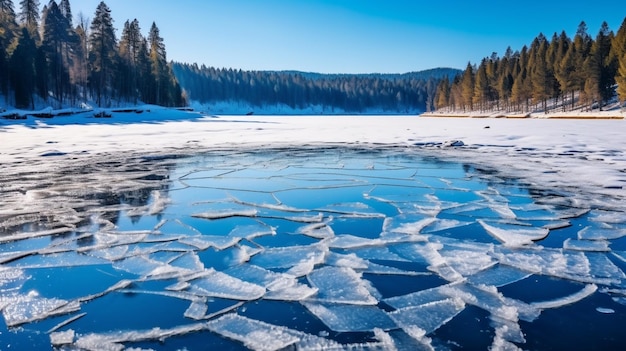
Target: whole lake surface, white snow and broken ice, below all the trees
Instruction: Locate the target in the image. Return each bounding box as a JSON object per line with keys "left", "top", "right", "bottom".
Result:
{"left": 0, "top": 107, "right": 626, "bottom": 350}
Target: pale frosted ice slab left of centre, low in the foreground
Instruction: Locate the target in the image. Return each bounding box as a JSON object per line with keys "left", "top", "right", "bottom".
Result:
{"left": 189, "top": 269, "right": 265, "bottom": 301}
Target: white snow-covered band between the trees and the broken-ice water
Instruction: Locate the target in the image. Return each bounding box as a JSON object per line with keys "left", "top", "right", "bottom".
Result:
{"left": 0, "top": 107, "right": 626, "bottom": 206}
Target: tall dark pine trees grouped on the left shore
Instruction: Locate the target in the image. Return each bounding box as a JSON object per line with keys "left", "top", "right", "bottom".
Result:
{"left": 0, "top": 0, "right": 184, "bottom": 109}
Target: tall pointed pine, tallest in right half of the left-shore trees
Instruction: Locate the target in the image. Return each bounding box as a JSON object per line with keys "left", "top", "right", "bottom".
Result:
{"left": 89, "top": 2, "right": 117, "bottom": 106}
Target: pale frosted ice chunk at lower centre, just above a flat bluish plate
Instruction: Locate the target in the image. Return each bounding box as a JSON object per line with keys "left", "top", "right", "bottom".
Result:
{"left": 307, "top": 266, "right": 378, "bottom": 305}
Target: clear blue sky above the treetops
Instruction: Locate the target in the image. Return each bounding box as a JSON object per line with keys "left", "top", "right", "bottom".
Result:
{"left": 59, "top": 0, "right": 626, "bottom": 73}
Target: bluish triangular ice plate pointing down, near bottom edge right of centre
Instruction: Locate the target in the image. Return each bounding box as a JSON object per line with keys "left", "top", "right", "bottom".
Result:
{"left": 389, "top": 299, "right": 465, "bottom": 335}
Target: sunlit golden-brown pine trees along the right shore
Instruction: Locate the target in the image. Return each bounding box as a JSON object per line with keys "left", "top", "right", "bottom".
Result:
{"left": 435, "top": 18, "right": 626, "bottom": 113}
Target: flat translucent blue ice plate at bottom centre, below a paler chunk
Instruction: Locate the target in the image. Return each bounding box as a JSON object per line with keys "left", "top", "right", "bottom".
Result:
{"left": 302, "top": 302, "right": 396, "bottom": 332}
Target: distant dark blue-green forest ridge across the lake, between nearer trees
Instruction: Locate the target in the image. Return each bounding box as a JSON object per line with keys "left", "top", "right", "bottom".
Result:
{"left": 173, "top": 63, "right": 459, "bottom": 113}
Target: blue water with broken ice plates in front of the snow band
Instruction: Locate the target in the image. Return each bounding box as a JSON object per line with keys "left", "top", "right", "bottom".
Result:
{"left": 0, "top": 146, "right": 626, "bottom": 350}
